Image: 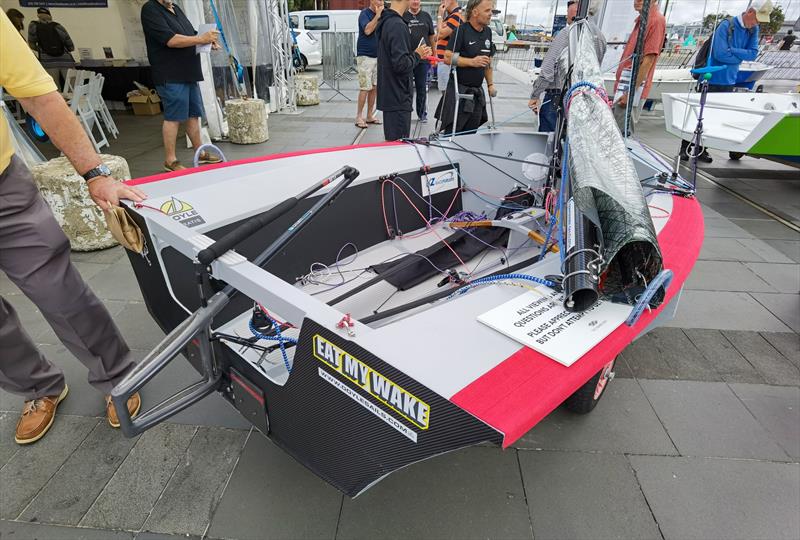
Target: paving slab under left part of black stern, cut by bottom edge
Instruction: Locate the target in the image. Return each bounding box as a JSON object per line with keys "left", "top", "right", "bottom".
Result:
{"left": 208, "top": 431, "right": 340, "bottom": 540}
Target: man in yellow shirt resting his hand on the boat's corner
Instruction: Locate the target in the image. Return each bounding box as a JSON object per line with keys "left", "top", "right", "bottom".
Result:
{"left": 0, "top": 14, "right": 144, "bottom": 444}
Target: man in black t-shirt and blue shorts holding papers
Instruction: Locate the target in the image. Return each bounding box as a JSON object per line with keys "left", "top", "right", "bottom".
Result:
{"left": 142, "top": 0, "right": 222, "bottom": 171}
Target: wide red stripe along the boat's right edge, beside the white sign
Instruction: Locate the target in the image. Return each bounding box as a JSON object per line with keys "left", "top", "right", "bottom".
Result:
{"left": 450, "top": 197, "right": 704, "bottom": 448}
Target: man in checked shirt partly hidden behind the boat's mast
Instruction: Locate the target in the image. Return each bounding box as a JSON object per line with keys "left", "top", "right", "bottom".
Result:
{"left": 528, "top": 0, "right": 606, "bottom": 132}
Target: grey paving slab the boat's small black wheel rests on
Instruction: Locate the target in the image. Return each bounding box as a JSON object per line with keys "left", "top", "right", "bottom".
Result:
{"left": 514, "top": 379, "right": 678, "bottom": 455}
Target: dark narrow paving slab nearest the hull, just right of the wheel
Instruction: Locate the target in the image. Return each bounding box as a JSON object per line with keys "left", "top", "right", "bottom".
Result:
{"left": 622, "top": 328, "right": 721, "bottom": 381}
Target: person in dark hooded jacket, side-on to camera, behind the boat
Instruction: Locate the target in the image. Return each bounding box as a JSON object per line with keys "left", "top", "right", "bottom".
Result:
{"left": 378, "top": 0, "right": 431, "bottom": 141}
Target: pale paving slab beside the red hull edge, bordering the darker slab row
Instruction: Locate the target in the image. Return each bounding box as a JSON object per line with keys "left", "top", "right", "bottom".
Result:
{"left": 665, "top": 290, "right": 797, "bottom": 332}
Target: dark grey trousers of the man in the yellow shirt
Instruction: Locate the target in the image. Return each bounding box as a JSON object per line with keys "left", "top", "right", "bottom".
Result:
{"left": 0, "top": 156, "right": 133, "bottom": 400}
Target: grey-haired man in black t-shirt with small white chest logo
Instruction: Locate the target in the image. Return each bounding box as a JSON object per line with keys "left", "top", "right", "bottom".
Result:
{"left": 436, "top": 0, "right": 497, "bottom": 133}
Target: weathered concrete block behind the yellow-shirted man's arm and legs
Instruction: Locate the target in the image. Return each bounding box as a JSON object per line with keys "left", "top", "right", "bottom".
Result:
{"left": 31, "top": 154, "right": 131, "bottom": 251}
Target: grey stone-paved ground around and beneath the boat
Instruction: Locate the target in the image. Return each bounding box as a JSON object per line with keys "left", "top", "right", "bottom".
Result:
{"left": 0, "top": 67, "right": 800, "bottom": 539}
